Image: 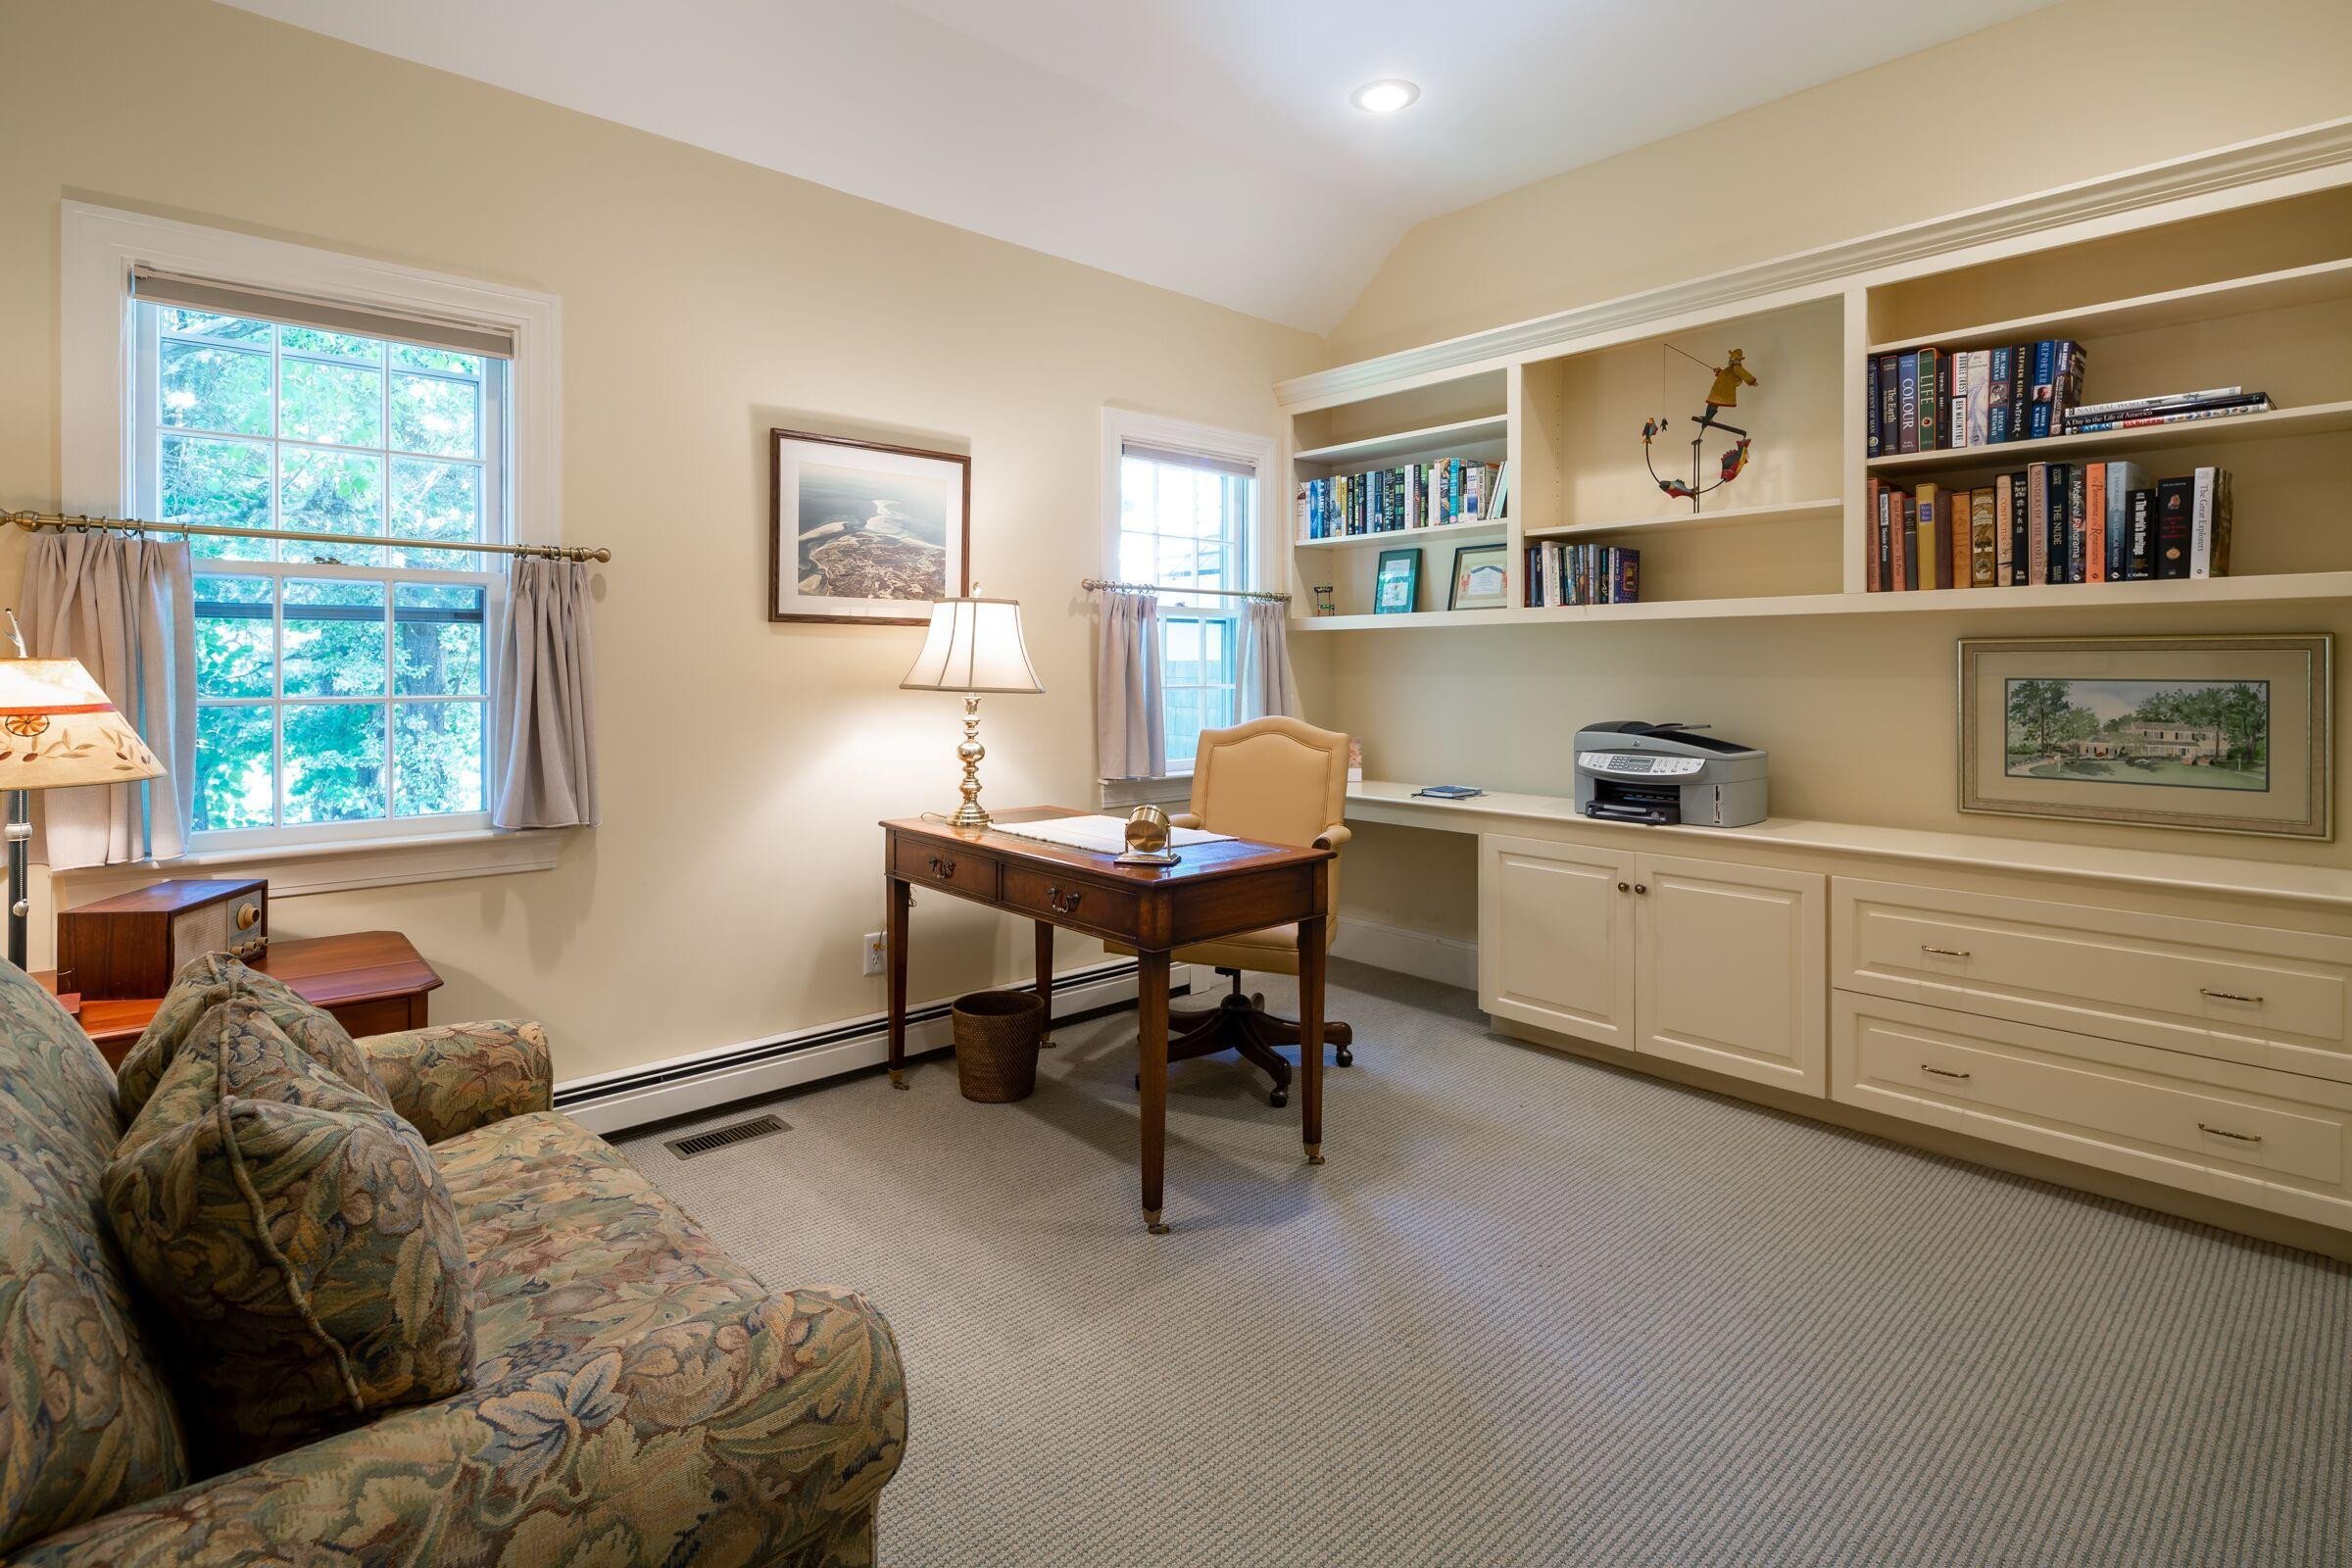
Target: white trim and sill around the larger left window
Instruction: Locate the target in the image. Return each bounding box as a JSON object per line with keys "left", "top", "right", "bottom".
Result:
{"left": 57, "top": 202, "right": 563, "bottom": 898}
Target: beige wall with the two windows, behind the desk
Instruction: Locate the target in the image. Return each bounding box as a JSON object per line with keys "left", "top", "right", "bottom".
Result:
{"left": 0, "top": 0, "right": 1317, "bottom": 1077}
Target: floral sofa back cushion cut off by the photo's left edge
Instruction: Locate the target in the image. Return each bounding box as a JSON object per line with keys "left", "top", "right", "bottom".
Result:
{"left": 0, "top": 959, "right": 188, "bottom": 1556}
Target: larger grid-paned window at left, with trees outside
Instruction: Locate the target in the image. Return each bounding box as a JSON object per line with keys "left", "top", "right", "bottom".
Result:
{"left": 134, "top": 301, "right": 508, "bottom": 849}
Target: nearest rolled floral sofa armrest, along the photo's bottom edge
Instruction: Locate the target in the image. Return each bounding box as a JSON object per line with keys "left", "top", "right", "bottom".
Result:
{"left": 12, "top": 1291, "right": 906, "bottom": 1568}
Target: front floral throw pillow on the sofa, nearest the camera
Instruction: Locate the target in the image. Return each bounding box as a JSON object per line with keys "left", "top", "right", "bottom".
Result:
{"left": 104, "top": 985, "right": 472, "bottom": 1472}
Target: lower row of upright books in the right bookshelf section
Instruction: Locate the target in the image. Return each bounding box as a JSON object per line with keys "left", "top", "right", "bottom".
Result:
{"left": 1863, "top": 464, "right": 2232, "bottom": 592}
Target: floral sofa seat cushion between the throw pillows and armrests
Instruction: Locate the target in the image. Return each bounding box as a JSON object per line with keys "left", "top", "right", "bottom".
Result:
{"left": 433, "top": 1112, "right": 769, "bottom": 1387}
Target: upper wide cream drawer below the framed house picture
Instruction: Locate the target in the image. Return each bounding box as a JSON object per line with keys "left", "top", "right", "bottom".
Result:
{"left": 1830, "top": 877, "right": 2352, "bottom": 1081}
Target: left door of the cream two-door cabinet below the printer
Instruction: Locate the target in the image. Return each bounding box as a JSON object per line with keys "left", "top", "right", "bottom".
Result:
{"left": 1477, "top": 832, "right": 1627, "bottom": 1049}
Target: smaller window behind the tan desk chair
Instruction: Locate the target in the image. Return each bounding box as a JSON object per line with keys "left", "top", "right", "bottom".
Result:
{"left": 1117, "top": 442, "right": 1258, "bottom": 771}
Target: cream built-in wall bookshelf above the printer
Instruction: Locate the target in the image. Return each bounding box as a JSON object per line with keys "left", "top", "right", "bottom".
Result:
{"left": 1277, "top": 160, "right": 2352, "bottom": 632}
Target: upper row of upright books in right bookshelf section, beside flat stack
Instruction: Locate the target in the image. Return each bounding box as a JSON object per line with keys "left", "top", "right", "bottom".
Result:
{"left": 1863, "top": 338, "right": 2088, "bottom": 459}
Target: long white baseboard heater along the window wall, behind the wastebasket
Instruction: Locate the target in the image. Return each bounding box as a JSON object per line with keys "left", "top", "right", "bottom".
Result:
{"left": 555, "top": 959, "right": 1193, "bottom": 1136}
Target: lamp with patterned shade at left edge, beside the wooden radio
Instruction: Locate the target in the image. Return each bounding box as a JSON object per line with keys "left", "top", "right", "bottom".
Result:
{"left": 0, "top": 639, "right": 163, "bottom": 968}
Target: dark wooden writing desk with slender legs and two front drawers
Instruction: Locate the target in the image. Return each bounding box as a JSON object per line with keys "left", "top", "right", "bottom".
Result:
{"left": 882, "top": 807, "right": 1331, "bottom": 1237}
